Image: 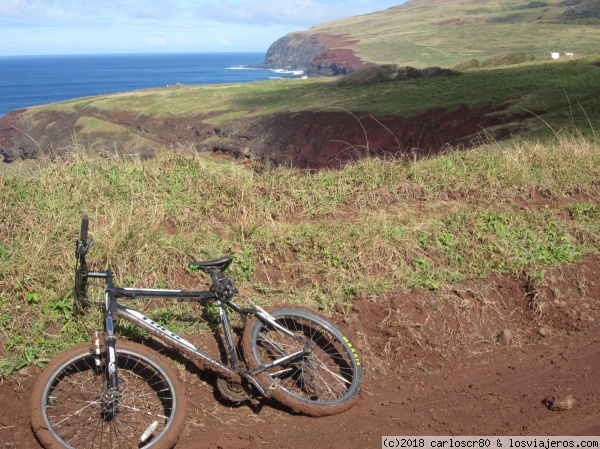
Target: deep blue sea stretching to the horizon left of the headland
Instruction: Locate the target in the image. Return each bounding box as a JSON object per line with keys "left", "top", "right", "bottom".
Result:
{"left": 0, "top": 53, "right": 298, "bottom": 117}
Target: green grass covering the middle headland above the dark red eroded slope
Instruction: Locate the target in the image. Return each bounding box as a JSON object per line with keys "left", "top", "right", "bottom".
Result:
{"left": 26, "top": 57, "right": 600, "bottom": 142}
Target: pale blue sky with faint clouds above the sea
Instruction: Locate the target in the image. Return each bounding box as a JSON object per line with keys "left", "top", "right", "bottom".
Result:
{"left": 0, "top": 0, "right": 405, "bottom": 56}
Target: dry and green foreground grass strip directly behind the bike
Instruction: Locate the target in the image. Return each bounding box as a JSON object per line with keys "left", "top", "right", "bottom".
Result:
{"left": 0, "top": 133, "right": 600, "bottom": 376}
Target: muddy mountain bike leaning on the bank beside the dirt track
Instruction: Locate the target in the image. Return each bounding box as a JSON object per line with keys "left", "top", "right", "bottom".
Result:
{"left": 31, "top": 216, "right": 363, "bottom": 449}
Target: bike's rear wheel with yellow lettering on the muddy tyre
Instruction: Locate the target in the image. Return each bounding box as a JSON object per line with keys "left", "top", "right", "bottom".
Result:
{"left": 243, "top": 307, "right": 363, "bottom": 416}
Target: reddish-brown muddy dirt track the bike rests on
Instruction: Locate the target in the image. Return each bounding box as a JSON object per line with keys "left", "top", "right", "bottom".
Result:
{"left": 0, "top": 256, "right": 600, "bottom": 449}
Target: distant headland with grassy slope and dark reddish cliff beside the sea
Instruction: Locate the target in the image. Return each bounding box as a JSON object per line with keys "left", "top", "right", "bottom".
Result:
{"left": 262, "top": 0, "right": 600, "bottom": 77}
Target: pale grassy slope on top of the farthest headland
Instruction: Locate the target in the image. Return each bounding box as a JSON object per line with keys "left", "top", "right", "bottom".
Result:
{"left": 300, "top": 0, "right": 600, "bottom": 67}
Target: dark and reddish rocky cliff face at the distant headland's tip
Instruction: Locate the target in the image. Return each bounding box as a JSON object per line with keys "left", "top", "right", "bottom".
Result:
{"left": 261, "top": 33, "right": 373, "bottom": 77}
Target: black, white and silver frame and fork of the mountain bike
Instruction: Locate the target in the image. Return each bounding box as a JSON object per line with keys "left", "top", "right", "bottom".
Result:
{"left": 82, "top": 268, "right": 312, "bottom": 402}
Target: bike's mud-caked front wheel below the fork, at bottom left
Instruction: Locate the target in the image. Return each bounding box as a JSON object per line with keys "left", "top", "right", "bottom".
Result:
{"left": 31, "top": 341, "right": 187, "bottom": 449}
